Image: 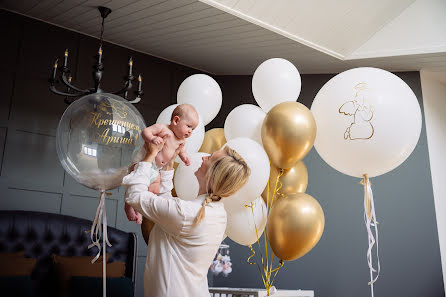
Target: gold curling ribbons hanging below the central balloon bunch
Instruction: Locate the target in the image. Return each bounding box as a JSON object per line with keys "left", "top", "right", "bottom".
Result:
{"left": 245, "top": 169, "right": 284, "bottom": 296}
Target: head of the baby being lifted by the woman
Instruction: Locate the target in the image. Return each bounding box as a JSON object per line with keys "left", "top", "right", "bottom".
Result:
{"left": 169, "top": 104, "right": 198, "bottom": 139}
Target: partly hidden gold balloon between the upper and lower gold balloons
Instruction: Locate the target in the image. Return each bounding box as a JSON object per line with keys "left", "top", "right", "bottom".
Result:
{"left": 262, "top": 161, "right": 308, "bottom": 203}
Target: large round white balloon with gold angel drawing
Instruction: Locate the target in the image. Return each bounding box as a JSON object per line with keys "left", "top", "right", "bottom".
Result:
{"left": 311, "top": 68, "right": 421, "bottom": 177}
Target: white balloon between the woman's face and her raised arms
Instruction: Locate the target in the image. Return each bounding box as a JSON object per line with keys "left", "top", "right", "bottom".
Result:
{"left": 174, "top": 153, "right": 209, "bottom": 200}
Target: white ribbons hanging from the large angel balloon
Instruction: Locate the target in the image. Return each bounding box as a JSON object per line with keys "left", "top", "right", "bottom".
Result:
{"left": 361, "top": 174, "right": 381, "bottom": 297}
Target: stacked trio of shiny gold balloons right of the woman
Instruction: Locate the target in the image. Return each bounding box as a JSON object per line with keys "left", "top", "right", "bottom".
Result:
{"left": 262, "top": 102, "right": 325, "bottom": 261}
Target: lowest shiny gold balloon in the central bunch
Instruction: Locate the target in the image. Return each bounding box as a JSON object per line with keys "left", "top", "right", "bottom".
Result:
{"left": 267, "top": 193, "right": 325, "bottom": 261}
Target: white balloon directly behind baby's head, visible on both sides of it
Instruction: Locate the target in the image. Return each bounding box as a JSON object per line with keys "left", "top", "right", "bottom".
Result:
{"left": 156, "top": 104, "right": 204, "bottom": 163}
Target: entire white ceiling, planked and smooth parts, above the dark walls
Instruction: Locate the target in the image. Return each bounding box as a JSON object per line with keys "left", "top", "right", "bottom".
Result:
{"left": 0, "top": 0, "right": 446, "bottom": 75}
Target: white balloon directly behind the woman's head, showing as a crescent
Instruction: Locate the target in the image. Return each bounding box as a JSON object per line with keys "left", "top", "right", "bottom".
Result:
{"left": 223, "top": 137, "right": 270, "bottom": 211}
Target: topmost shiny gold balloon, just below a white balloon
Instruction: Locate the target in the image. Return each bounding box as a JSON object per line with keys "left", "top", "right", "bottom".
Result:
{"left": 262, "top": 102, "right": 316, "bottom": 169}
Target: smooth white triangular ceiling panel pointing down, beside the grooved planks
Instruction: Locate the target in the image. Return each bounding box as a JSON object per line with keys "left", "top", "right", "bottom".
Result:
{"left": 202, "top": 0, "right": 415, "bottom": 58}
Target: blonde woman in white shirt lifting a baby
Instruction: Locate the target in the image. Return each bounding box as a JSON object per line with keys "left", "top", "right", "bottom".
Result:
{"left": 123, "top": 139, "right": 250, "bottom": 297}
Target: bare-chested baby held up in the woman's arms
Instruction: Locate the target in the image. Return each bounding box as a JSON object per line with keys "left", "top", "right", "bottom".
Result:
{"left": 125, "top": 104, "right": 198, "bottom": 224}
